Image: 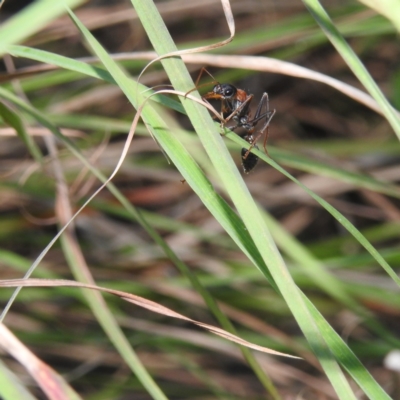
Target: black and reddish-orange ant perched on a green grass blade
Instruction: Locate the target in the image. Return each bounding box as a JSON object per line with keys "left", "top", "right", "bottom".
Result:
{"left": 188, "top": 67, "right": 275, "bottom": 174}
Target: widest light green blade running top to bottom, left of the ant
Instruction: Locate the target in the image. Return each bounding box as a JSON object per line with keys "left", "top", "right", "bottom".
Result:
{"left": 132, "top": 0, "right": 355, "bottom": 399}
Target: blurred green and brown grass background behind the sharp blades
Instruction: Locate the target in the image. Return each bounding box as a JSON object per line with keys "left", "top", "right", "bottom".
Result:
{"left": 0, "top": 0, "right": 400, "bottom": 400}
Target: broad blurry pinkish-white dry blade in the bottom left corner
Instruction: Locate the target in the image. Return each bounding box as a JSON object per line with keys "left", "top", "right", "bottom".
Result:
{"left": 0, "top": 323, "right": 81, "bottom": 400}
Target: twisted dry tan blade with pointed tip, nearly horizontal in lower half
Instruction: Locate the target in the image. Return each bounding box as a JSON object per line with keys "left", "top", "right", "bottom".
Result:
{"left": 0, "top": 279, "right": 300, "bottom": 359}
